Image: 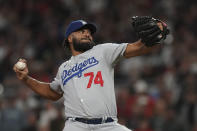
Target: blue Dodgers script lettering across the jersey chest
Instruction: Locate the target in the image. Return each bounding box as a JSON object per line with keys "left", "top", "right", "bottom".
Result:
{"left": 61, "top": 57, "right": 99, "bottom": 86}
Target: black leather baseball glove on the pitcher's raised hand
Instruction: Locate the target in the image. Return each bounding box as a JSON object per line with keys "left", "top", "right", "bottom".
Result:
{"left": 132, "top": 16, "right": 169, "bottom": 47}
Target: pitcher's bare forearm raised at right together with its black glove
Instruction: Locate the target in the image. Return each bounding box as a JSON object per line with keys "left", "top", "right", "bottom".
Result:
{"left": 124, "top": 16, "right": 169, "bottom": 58}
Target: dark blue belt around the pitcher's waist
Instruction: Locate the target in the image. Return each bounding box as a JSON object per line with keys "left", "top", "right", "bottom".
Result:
{"left": 67, "top": 117, "right": 114, "bottom": 124}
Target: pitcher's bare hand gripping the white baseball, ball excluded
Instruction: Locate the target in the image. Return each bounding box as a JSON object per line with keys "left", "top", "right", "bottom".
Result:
{"left": 13, "top": 59, "right": 29, "bottom": 81}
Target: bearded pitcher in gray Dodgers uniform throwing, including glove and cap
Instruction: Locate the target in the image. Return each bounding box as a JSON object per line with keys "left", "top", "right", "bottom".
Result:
{"left": 13, "top": 17, "right": 169, "bottom": 131}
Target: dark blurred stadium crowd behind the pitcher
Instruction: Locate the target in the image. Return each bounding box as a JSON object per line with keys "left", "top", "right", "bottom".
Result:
{"left": 0, "top": 0, "right": 197, "bottom": 131}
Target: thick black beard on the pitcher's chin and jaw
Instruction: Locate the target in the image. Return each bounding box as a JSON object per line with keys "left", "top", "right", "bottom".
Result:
{"left": 73, "top": 38, "right": 95, "bottom": 52}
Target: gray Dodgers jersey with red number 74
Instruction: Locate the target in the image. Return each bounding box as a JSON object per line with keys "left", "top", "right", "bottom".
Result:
{"left": 50, "top": 43, "right": 127, "bottom": 118}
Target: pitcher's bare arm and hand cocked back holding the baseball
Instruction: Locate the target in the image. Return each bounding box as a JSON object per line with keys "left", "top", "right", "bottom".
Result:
{"left": 13, "top": 59, "right": 62, "bottom": 101}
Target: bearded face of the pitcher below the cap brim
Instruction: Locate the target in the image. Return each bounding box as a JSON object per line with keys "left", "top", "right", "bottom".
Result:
{"left": 72, "top": 29, "right": 95, "bottom": 52}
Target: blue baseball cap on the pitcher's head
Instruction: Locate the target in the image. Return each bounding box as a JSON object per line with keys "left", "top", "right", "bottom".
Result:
{"left": 65, "top": 20, "right": 96, "bottom": 39}
